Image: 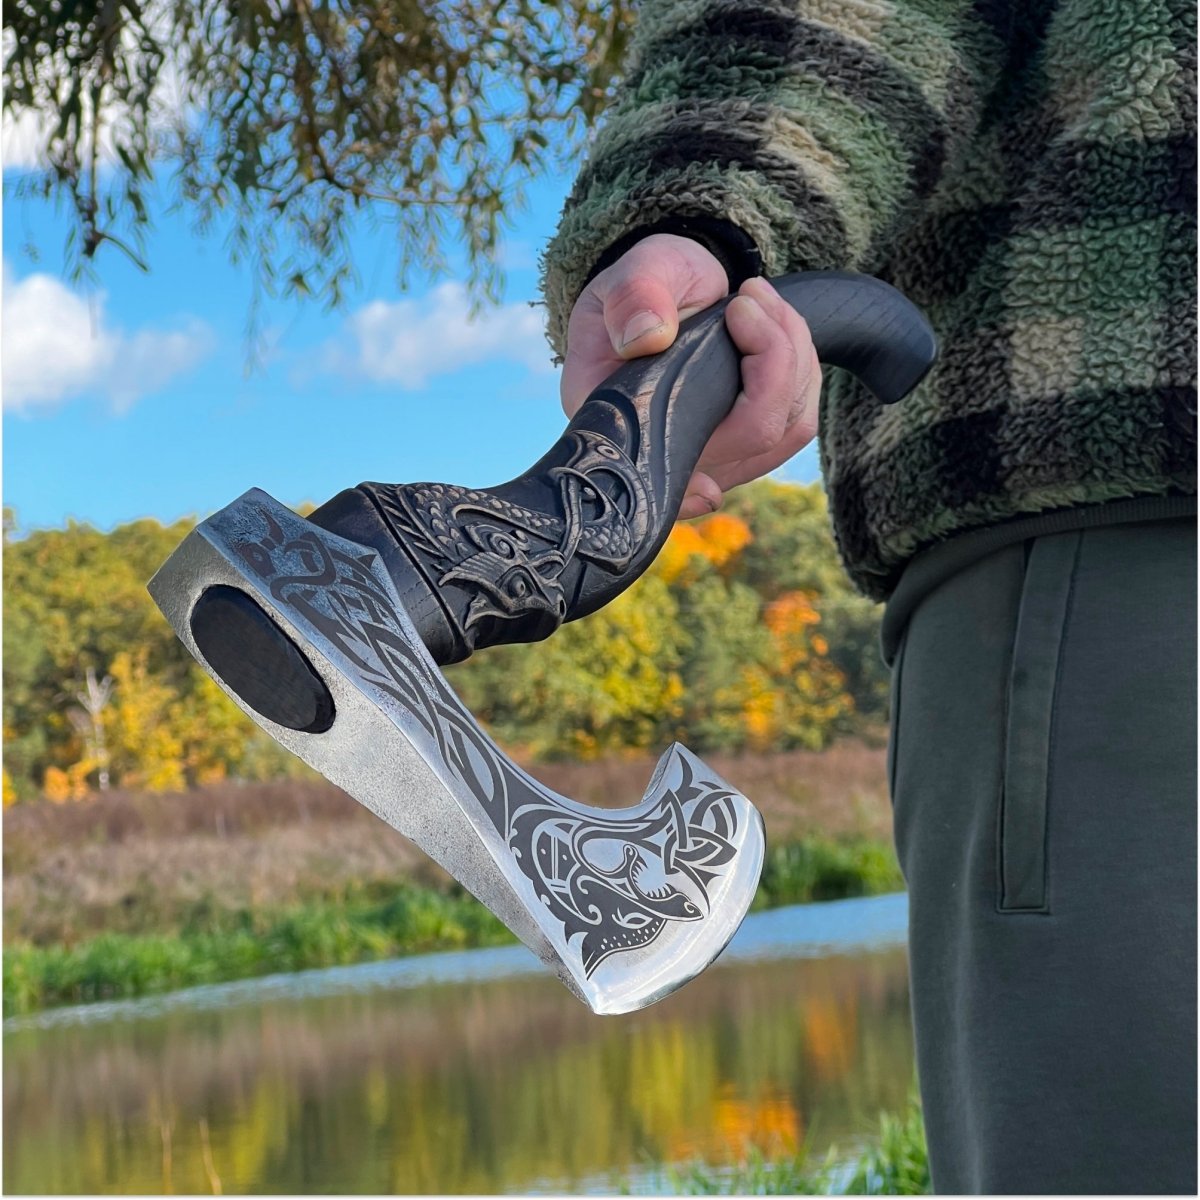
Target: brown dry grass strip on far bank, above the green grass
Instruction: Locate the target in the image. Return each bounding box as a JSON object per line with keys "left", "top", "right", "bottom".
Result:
{"left": 4, "top": 742, "right": 890, "bottom": 944}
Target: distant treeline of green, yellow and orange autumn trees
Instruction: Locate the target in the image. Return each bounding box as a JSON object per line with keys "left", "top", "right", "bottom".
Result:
{"left": 4, "top": 480, "right": 887, "bottom": 805}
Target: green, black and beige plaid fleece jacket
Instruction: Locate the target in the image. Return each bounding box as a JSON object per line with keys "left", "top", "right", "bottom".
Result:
{"left": 542, "top": 0, "right": 1196, "bottom": 598}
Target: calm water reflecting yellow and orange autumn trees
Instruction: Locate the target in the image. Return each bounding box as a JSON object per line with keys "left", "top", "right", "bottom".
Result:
{"left": 4, "top": 895, "right": 912, "bottom": 1194}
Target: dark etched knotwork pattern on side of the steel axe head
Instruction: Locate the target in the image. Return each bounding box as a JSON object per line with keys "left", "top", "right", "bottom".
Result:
{"left": 236, "top": 508, "right": 738, "bottom": 977}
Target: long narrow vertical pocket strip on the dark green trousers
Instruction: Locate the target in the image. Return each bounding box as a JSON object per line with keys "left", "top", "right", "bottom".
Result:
{"left": 997, "top": 530, "right": 1082, "bottom": 913}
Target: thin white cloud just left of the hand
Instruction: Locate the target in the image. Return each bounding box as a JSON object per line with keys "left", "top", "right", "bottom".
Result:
{"left": 324, "top": 283, "right": 553, "bottom": 390}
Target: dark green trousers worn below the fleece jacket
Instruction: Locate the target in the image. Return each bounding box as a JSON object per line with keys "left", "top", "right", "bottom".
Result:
{"left": 884, "top": 518, "right": 1196, "bottom": 1193}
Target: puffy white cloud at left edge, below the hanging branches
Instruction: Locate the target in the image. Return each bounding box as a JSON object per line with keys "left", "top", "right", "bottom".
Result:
{"left": 0, "top": 268, "right": 212, "bottom": 413}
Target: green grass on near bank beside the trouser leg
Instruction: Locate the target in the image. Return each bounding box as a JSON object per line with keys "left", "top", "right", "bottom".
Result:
{"left": 665, "top": 1090, "right": 934, "bottom": 1196}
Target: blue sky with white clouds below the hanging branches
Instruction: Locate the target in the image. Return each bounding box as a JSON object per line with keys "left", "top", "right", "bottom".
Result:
{"left": 2, "top": 151, "right": 816, "bottom": 529}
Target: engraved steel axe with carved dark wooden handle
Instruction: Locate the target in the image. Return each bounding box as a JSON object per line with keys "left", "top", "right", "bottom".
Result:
{"left": 150, "top": 271, "right": 936, "bottom": 1013}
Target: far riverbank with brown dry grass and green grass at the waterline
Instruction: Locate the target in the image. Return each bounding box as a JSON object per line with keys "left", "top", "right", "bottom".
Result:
{"left": 4, "top": 743, "right": 902, "bottom": 1015}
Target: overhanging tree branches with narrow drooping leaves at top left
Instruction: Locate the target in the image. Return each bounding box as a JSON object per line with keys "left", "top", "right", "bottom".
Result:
{"left": 4, "top": 0, "right": 631, "bottom": 314}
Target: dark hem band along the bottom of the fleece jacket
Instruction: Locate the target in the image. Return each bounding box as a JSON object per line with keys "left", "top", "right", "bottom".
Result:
{"left": 880, "top": 496, "right": 1196, "bottom": 666}
